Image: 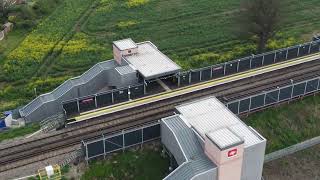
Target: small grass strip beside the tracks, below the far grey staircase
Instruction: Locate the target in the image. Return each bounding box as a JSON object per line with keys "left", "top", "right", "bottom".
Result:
{"left": 0, "top": 124, "right": 40, "bottom": 142}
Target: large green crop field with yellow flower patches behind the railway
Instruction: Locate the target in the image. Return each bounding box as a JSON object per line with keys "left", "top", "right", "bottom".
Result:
{"left": 0, "top": 0, "right": 320, "bottom": 114}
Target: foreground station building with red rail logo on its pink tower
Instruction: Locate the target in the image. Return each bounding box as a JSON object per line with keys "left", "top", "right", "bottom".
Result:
{"left": 161, "top": 97, "right": 266, "bottom": 180}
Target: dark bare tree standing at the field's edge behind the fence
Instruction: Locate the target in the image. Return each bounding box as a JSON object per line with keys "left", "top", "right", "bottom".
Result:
{"left": 238, "top": 0, "right": 284, "bottom": 53}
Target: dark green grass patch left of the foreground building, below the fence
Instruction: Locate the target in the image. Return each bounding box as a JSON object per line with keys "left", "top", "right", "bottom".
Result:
{"left": 81, "top": 150, "right": 169, "bottom": 180}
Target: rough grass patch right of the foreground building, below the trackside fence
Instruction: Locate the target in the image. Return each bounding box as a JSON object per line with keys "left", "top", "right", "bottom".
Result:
{"left": 243, "top": 95, "right": 320, "bottom": 153}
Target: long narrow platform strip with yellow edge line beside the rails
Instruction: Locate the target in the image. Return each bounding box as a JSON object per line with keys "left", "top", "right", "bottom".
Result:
{"left": 75, "top": 53, "right": 320, "bottom": 122}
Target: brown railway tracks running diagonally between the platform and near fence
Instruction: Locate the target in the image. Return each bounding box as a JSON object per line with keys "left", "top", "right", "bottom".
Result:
{"left": 0, "top": 57, "right": 320, "bottom": 172}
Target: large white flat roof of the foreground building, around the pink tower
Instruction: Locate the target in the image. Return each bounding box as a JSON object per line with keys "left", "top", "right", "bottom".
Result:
{"left": 176, "top": 97, "right": 264, "bottom": 147}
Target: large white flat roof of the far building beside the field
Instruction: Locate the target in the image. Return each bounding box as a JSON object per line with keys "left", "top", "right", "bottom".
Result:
{"left": 124, "top": 41, "right": 181, "bottom": 79}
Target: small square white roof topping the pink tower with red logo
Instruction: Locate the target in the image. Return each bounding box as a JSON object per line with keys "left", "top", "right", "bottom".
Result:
{"left": 207, "top": 128, "right": 243, "bottom": 149}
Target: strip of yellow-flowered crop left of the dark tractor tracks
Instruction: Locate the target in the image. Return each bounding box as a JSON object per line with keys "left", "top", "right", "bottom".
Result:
{"left": 3, "top": 0, "right": 92, "bottom": 80}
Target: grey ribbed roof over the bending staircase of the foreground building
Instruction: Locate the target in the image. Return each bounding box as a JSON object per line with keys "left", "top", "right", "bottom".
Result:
{"left": 162, "top": 115, "right": 217, "bottom": 180}
